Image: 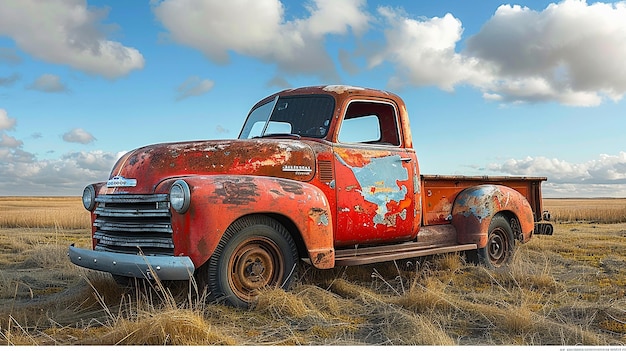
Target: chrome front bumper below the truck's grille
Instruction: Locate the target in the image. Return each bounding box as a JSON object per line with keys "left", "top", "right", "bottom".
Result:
{"left": 68, "top": 245, "right": 195, "bottom": 280}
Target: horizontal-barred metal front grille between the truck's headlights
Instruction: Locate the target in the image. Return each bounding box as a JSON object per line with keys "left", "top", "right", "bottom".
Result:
{"left": 93, "top": 194, "right": 174, "bottom": 255}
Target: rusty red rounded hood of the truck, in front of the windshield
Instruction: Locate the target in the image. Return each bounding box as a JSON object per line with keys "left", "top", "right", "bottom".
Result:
{"left": 108, "top": 139, "right": 315, "bottom": 194}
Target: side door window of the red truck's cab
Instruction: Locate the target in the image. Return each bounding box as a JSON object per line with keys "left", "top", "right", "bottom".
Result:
{"left": 338, "top": 101, "right": 400, "bottom": 146}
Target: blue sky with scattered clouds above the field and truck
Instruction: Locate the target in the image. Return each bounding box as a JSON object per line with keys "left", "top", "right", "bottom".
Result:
{"left": 0, "top": 0, "right": 626, "bottom": 197}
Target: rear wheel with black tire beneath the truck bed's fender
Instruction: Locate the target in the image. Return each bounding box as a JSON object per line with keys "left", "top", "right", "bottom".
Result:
{"left": 477, "top": 214, "right": 515, "bottom": 269}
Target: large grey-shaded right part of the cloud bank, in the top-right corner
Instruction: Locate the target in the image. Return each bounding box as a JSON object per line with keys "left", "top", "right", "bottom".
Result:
{"left": 464, "top": 0, "right": 626, "bottom": 106}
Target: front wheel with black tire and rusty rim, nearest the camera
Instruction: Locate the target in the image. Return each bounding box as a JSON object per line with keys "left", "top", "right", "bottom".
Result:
{"left": 201, "top": 215, "right": 298, "bottom": 308}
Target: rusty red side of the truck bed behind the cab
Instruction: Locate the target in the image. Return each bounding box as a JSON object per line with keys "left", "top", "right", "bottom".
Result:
{"left": 420, "top": 175, "right": 548, "bottom": 226}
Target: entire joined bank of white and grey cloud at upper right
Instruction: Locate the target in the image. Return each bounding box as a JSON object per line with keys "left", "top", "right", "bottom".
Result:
{"left": 366, "top": 0, "right": 626, "bottom": 106}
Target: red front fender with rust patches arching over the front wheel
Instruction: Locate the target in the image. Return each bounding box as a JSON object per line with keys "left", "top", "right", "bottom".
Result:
{"left": 162, "top": 175, "right": 335, "bottom": 268}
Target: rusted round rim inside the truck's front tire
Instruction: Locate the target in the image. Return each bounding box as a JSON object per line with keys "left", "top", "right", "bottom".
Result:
{"left": 228, "top": 237, "right": 284, "bottom": 302}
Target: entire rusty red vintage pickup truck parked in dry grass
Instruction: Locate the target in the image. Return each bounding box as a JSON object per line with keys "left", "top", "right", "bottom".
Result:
{"left": 69, "top": 85, "right": 553, "bottom": 306}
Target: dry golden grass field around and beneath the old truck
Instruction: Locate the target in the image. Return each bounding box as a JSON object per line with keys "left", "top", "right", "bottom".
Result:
{"left": 0, "top": 198, "right": 626, "bottom": 345}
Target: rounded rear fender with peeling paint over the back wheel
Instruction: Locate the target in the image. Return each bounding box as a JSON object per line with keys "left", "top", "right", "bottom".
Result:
{"left": 452, "top": 185, "right": 535, "bottom": 248}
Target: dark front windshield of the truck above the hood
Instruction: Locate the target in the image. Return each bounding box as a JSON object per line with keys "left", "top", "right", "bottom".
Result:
{"left": 239, "top": 95, "right": 335, "bottom": 139}
